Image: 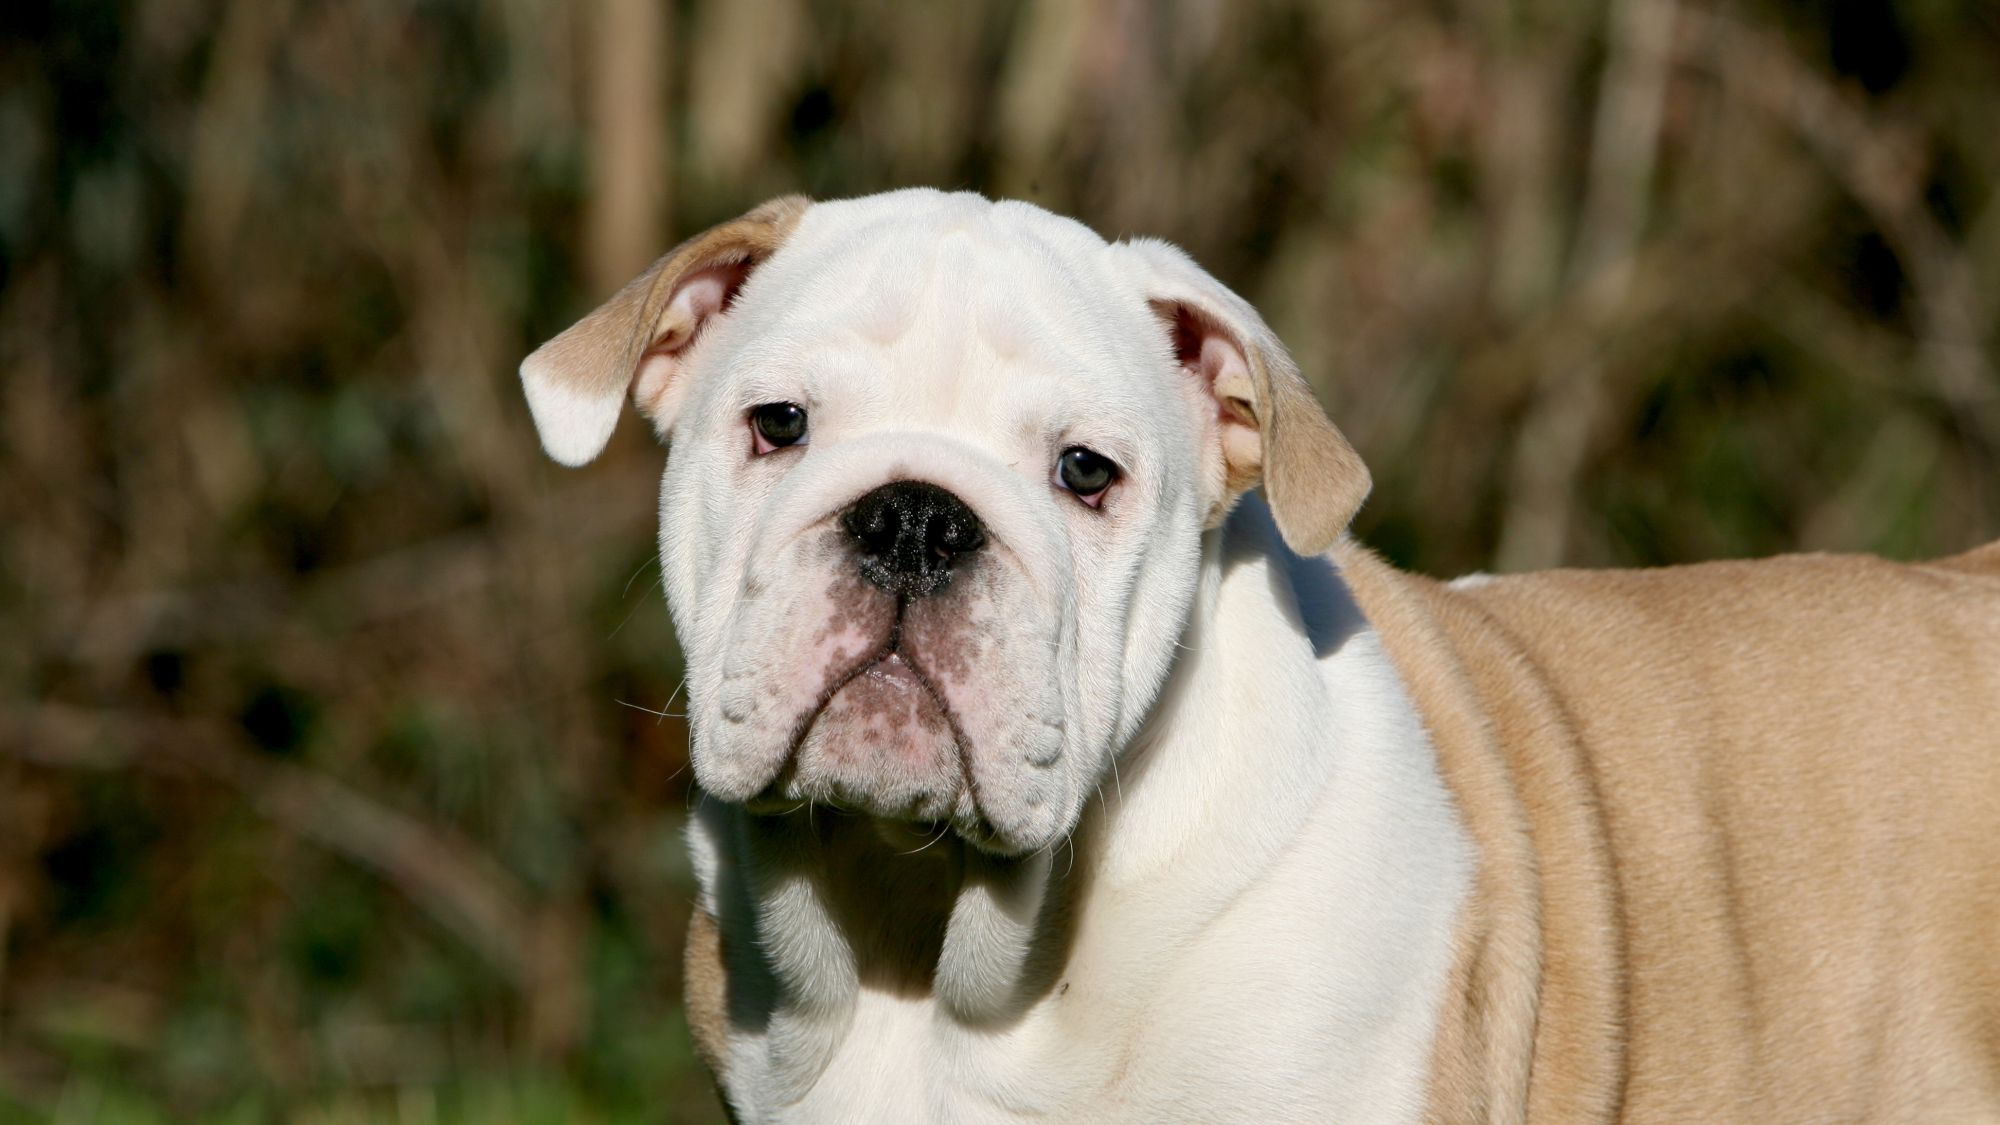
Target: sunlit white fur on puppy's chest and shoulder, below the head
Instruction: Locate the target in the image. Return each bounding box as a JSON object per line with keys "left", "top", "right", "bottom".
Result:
{"left": 694, "top": 502, "right": 1472, "bottom": 1121}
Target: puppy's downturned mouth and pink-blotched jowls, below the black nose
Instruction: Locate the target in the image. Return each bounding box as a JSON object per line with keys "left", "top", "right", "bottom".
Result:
{"left": 708, "top": 528, "right": 1078, "bottom": 857}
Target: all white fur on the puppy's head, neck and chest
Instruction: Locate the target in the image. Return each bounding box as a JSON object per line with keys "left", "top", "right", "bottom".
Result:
{"left": 530, "top": 192, "right": 1472, "bottom": 1123}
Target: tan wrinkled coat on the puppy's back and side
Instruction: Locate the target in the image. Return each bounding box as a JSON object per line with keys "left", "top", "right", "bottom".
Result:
{"left": 1342, "top": 544, "right": 2000, "bottom": 1123}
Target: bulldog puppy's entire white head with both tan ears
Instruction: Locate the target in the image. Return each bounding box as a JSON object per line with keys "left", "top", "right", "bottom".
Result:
{"left": 522, "top": 190, "right": 1368, "bottom": 855}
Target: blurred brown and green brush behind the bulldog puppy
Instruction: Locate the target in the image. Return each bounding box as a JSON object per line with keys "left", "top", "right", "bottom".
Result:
{"left": 0, "top": 0, "right": 2000, "bottom": 1123}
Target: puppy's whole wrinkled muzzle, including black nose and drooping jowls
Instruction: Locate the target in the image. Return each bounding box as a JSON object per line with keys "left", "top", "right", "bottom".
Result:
{"left": 694, "top": 438, "right": 1078, "bottom": 855}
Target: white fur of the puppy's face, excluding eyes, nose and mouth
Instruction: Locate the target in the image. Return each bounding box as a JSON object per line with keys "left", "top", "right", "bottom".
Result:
{"left": 660, "top": 194, "right": 1204, "bottom": 855}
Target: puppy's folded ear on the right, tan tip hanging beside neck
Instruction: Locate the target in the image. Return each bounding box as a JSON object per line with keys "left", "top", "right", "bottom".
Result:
{"left": 1124, "top": 238, "right": 1370, "bottom": 554}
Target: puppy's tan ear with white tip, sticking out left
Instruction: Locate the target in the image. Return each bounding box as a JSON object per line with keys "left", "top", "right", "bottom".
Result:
{"left": 520, "top": 196, "right": 812, "bottom": 464}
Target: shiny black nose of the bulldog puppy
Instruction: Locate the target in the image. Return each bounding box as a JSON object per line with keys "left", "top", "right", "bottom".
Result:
{"left": 840, "top": 480, "right": 986, "bottom": 599}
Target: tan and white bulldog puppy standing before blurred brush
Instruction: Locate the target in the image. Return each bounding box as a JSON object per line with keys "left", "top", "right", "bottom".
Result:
{"left": 520, "top": 190, "right": 2000, "bottom": 1123}
